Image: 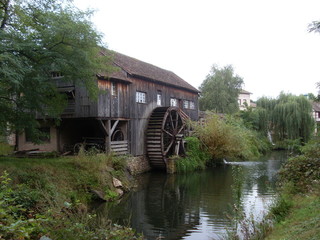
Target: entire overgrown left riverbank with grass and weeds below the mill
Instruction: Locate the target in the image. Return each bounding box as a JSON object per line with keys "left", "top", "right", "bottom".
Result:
{"left": 0, "top": 154, "right": 142, "bottom": 240}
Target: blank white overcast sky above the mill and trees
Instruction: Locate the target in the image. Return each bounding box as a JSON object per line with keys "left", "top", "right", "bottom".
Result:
{"left": 74, "top": 0, "right": 320, "bottom": 100}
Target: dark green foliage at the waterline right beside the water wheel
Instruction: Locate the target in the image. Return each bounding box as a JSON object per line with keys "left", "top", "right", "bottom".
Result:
{"left": 175, "top": 137, "right": 210, "bottom": 172}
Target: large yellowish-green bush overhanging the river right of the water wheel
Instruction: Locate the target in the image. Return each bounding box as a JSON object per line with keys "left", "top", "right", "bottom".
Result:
{"left": 194, "top": 113, "right": 269, "bottom": 161}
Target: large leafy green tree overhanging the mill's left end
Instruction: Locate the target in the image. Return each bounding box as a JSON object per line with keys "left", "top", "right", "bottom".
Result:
{"left": 0, "top": 0, "right": 112, "bottom": 140}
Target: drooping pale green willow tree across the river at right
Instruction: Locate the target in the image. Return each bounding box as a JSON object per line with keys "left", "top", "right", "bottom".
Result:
{"left": 257, "top": 93, "right": 314, "bottom": 142}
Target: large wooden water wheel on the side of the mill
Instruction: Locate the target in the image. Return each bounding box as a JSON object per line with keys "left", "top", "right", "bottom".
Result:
{"left": 146, "top": 107, "right": 189, "bottom": 169}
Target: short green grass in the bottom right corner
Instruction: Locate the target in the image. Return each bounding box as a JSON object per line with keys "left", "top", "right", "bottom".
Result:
{"left": 266, "top": 194, "right": 320, "bottom": 240}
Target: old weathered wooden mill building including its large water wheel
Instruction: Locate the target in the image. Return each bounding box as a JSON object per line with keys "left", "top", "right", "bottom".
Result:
{"left": 17, "top": 51, "right": 199, "bottom": 168}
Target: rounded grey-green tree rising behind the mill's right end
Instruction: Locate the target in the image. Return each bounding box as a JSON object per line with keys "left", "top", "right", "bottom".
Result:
{"left": 199, "top": 65, "right": 243, "bottom": 113}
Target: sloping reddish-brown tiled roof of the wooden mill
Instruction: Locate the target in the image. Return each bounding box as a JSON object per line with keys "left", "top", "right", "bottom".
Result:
{"left": 101, "top": 50, "right": 199, "bottom": 93}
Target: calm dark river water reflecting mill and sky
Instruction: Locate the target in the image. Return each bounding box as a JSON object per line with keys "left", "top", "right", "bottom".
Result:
{"left": 96, "top": 152, "right": 287, "bottom": 240}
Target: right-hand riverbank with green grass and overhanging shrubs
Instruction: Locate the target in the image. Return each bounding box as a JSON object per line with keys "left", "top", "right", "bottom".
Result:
{"left": 248, "top": 138, "right": 320, "bottom": 240}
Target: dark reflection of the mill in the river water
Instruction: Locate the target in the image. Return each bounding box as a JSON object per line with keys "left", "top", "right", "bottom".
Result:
{"left": 144, "top": 173, "right": 200, "bottom": 239}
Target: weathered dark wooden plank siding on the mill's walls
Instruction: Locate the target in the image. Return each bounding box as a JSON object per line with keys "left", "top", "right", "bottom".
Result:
{"left": 52, "top": 77, "right": 198, "bottom": 156}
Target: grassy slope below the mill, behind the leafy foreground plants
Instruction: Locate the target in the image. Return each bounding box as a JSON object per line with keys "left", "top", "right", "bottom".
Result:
{"left": 0, "top": 154, "right": 129, "bottom": 205}
